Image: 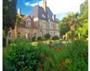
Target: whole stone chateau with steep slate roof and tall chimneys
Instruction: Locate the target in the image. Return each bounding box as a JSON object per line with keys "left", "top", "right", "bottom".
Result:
{"left": 8, "top": 0, "right": 59, "bottom": 39}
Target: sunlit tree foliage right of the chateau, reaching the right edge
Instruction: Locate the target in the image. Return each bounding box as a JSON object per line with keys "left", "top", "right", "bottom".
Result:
{"left": 60, "top": 0, "right": 88, "bottom": 39}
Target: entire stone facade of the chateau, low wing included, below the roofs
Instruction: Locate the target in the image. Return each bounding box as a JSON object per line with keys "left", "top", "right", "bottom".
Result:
{"left": 10, "top": 19, "right": 59, "bottom": 39}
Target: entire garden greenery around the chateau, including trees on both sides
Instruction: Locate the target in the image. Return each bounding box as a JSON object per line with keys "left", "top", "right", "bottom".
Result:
{"left": 3, "top": 0, "right": 88, "bottom": 71}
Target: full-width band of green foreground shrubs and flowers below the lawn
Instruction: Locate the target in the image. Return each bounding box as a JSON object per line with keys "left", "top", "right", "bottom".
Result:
{"left": 3, "top": 39, "right": 88, "bottom": 71}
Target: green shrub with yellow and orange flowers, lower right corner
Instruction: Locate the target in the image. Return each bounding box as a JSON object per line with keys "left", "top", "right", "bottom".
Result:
{"left": 59, "top": 40, "right": 88, "bottom": 71}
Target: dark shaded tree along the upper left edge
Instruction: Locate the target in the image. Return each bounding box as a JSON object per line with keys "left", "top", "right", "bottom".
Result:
{"left": 3, "top": 0, "right": 17, "bottom": 46}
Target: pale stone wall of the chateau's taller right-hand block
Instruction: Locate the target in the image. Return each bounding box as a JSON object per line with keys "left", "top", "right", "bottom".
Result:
{"left": 39, "top": 19, "right": 59, "bottom": 37}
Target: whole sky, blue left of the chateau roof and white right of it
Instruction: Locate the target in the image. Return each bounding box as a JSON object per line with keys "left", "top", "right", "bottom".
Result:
{"left": 17, "top": 0, "right": 85, "bottom": 19}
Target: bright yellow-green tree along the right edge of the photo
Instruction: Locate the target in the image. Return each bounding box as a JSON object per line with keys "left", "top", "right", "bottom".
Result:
{"left": 76, "top": 0, "right": 88, "bottom": 39}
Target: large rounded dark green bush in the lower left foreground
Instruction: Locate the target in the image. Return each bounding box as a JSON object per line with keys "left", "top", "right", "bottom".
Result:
{"left": 3, "top": 39, "right": 40, "bottom": 71}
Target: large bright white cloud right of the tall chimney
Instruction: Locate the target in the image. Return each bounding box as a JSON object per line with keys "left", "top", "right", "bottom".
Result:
{"left": 47, "top": 0, "right": 85, "bottom": 14}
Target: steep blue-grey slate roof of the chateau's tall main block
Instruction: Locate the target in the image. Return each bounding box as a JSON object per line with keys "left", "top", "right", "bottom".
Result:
{"left": 30, "top": 5, "right": 54, "bottom": 20}
